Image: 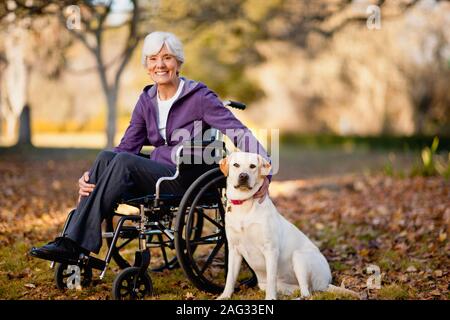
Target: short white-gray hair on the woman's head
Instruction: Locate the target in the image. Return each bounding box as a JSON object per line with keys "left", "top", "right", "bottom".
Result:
{"left": 141, "top": 31, "right": 184, "bottom": 67}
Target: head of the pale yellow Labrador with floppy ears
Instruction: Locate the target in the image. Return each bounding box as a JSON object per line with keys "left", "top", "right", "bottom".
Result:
{"left": 219, "top": 152, "right": 271, "bottom": 198}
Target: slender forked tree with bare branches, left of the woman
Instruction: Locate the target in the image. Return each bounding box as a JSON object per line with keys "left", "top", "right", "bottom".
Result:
{"left": 0, "top": 0, "right": 154, "bottom": 147}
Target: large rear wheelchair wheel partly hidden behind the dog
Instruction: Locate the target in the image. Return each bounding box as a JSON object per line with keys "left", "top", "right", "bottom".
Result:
{"left": 175, "top": 168, "right": 257, "bottom": 294}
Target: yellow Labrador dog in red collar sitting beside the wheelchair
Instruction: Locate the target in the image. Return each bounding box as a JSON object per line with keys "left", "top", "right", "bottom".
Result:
{"left": 217, "top": 152, "right": 354, "bottom": 299}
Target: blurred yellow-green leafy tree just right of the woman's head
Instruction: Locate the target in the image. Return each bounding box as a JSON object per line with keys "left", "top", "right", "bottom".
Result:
{"left": 154, "top": 0, "right": 281, "bottom": 103}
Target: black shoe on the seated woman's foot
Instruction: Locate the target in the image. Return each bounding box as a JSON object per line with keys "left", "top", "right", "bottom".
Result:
{"left": 30, "top": 237, "right": 89, "bottom": 263}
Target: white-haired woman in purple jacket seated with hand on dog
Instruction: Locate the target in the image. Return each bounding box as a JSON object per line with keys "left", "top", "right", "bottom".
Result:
{"left": 31, "top": 32, "right": 270, "bottom": 260}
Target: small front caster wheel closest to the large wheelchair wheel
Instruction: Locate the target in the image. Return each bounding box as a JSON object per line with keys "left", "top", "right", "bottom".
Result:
{"left": 112, "top": 267, "right": 153, "bottom": 300}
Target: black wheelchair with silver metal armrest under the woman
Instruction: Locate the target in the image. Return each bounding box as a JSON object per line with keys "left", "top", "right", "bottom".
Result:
{"left": 51, "top": 101, "right": 257, "bottom": 300}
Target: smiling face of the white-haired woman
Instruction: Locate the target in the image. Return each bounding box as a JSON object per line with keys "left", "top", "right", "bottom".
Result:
{"left": 146, "top": 44, "right": 181, "bottom": 85}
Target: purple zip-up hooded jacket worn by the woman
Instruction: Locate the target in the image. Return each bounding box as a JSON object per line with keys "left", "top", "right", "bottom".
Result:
{"left": 113, "top": 78, "right": 271, "bottom": 180}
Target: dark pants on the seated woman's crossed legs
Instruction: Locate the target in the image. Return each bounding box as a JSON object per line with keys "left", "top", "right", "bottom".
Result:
{"left": 65, "top": 151, "right": 184, "bottom": 253}
